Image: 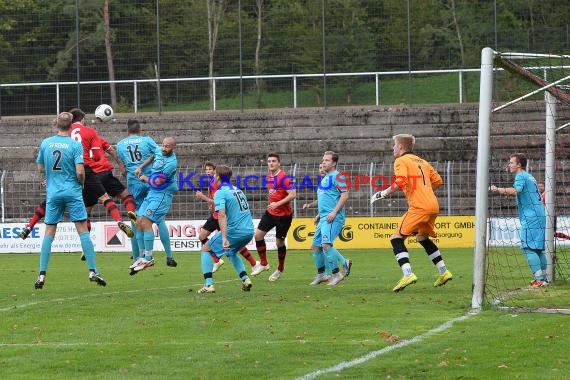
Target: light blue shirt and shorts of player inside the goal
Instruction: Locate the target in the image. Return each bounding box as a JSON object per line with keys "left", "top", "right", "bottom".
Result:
{"left": 513, "top": 171, "right": 546, "bottom": 249}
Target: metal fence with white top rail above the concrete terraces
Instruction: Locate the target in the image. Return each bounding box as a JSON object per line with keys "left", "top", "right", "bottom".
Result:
{"left": 0, "top": 69, "right": 480, "bottom": 116}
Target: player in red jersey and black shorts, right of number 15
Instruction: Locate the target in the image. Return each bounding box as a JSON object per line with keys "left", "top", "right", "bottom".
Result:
{"left": 251, "top": 153, "right": 297, "bottom": 282}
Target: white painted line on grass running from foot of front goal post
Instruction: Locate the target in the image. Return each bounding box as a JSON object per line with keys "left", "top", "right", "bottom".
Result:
{"left": 297, "top": 311, "right": 477, "bottom": 380}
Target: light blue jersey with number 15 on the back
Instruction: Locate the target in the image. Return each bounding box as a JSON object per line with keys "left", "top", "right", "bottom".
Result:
{"left": 214, "top": 182, "right": 253, "bottom": 241}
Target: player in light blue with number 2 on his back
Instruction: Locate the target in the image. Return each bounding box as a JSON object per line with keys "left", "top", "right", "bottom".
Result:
{"left": 35, "top": 112, "right": 107, "bottom": 289}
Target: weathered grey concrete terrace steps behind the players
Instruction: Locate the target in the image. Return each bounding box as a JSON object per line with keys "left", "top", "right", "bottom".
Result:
{"left": 0, "top": 104, "right": 566, "bottom": 169}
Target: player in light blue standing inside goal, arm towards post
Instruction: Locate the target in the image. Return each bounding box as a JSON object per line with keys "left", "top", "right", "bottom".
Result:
{"left": 489, "top": 153, "right": 549, "bottom": 288}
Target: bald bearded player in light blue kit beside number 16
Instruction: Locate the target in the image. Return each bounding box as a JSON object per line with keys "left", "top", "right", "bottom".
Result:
{"left": 130, "top": 137, "right": 178, "bottom": 274}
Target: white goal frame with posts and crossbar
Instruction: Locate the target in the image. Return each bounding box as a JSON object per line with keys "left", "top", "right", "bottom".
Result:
{"left": 471, "top": 47, "right": 570, "bottom": 311}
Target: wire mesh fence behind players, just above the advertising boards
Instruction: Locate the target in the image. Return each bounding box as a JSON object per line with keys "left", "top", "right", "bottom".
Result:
{"left": 0, "top": 161, "right": 476, "bottom": 222}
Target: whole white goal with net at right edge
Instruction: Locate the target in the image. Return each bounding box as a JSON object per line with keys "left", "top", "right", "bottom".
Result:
{"left": 472, "top": 48, "right": 570, "bottom": 313}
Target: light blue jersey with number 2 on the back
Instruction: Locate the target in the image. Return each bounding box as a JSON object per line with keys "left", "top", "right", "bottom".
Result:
{"left": 36, "top": 135, "right": 83, "bottom": 200}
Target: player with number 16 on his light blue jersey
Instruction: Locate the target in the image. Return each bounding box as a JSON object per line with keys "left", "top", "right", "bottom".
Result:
{"left": 117, "top": 119, "right": 178, "bottom": 273}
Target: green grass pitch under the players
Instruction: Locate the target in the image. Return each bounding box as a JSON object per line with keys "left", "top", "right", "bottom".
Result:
{"left": 0, "top": 249, "right": 570, "bottom": 379}
